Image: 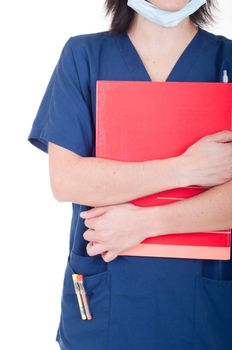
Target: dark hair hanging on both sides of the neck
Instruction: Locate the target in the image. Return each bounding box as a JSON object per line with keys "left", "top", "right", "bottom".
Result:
{"left": 105, "top": 0, "right": 217, "bottom": 33}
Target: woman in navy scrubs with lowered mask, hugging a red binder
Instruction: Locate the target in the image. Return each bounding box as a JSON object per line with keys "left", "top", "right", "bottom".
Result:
{"left": 28, "top": 0, "right": 232, "bottom": 350}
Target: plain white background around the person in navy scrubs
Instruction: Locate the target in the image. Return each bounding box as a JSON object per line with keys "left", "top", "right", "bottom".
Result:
{"left": 0, "top": 0, "right": 232, "bottom": 350}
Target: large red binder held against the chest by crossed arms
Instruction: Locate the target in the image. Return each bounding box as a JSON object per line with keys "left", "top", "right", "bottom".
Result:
{"left": 96, "top": 80, "right": 232, "bottom": 260}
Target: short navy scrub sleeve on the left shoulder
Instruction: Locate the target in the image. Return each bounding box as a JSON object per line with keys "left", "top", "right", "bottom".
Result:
{"left": 28, "top": 37, "right": 94, "bottom": 156}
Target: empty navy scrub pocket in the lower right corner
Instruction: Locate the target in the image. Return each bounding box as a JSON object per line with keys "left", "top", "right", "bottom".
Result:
{"left": 193, "top": 275, "right": 232, "bottom": 350}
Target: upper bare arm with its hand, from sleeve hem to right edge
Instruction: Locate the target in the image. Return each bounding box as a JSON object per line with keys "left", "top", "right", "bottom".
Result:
{"left": 48, "top": 130, "right": 232, "bottom": 206}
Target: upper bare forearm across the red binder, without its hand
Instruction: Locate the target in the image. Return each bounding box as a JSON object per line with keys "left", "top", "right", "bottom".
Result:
{"left": 59, "top": 157, "right": 186, "bottom": 206}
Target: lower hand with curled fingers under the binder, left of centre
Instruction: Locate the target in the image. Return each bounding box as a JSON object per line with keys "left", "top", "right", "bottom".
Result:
{"left": 80, "top": 203, "right": 150, "bottom": 262}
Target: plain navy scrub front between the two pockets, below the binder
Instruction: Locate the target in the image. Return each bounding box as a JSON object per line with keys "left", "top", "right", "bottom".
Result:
{"left": 109, "top": 256, "right": 199, "bottom": 350}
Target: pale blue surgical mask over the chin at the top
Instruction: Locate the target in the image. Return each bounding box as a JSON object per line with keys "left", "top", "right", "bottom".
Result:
{"left": 127, "top": 0, "right": 207, "bottom": 27}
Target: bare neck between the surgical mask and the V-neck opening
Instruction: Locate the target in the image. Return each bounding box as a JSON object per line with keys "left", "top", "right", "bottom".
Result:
{"left": 127, "top": 12, "right": 198, "bottom": 55}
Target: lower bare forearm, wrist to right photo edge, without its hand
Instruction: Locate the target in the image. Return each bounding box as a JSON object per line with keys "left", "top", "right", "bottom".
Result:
{"left": 145, "top": 181, "right": 232, "bottom": 236}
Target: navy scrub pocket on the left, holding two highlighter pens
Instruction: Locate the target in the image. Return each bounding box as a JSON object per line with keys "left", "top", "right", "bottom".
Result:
{"left": 56, "top": 251, "right": 110, "bottom": 350}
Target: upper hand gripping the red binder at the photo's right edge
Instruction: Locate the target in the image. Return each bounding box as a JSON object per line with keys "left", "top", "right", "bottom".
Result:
{"left": 180, "top": 130, "right": 232, "bottom": 187}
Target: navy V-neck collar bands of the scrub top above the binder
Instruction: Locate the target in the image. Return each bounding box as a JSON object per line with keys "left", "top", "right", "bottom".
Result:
{"left": 115, "top": 27, "right": 204, "bottom": 82}
